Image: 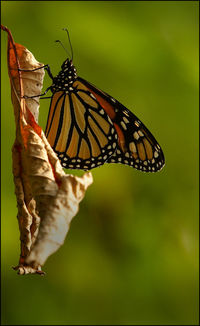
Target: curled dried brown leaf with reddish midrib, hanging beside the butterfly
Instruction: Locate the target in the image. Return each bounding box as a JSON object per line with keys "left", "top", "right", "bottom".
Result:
{"left": 2, "top": 26, "right": 93, "bottom": 274}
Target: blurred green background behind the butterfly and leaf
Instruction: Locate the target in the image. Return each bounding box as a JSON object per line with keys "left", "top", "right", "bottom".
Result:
{"left": 1, "top": 1, "right": 199, "bottom": 325}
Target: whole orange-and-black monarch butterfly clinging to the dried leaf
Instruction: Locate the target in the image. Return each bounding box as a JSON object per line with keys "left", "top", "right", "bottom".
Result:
{"left": 27, "top": 30, "right": 164, "bottom": 172}
